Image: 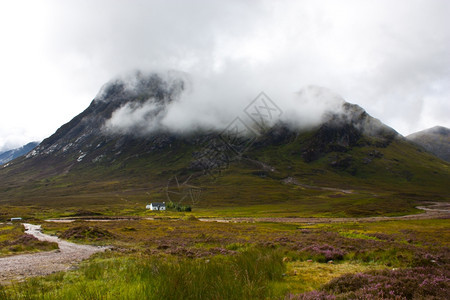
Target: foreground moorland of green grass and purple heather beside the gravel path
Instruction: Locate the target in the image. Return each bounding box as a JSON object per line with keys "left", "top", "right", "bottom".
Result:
{"left": 0, "top": 217, "right": 450, "bottom": 299}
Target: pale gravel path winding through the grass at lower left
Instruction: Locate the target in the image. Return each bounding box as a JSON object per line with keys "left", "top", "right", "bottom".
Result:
{"left": 0, "top": 224, "right": 107, "bottom": 283}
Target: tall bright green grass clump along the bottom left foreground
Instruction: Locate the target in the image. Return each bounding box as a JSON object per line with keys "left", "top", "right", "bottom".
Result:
{"left": 0, "top": 248, "right": 286, "bottom": 299}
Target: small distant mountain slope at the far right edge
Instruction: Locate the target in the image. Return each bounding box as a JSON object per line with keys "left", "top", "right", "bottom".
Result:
{"left": 406, "top": 126, "right": 450, "bottom": 162}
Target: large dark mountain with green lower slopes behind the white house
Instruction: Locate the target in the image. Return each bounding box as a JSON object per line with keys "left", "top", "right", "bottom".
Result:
{"left": 0, "top": 73, "right": 450, "bottom": 216}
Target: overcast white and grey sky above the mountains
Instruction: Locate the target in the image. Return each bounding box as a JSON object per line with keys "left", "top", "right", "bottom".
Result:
{"left": 0, "top": 0, "right": 450, "bottom": 150}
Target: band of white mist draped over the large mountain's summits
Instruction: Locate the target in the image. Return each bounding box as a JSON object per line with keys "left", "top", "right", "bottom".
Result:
{"left": 100, "top": 71, "right": 345, "bottom": 136}
